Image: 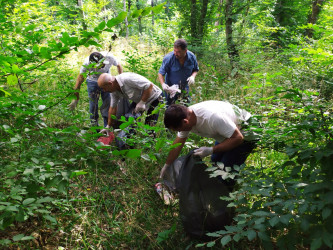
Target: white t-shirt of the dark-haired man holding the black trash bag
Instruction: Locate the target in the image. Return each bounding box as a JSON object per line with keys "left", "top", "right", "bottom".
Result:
{"left": 177, "top": 101, "right": 251, "bottom": 142}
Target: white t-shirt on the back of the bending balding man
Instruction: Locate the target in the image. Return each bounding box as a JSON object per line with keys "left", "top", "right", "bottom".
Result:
{"left": 110, "top": 72, "right": 162, "bottom": 108}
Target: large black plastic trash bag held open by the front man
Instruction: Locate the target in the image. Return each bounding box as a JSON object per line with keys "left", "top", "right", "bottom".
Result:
{"left": 163, "top": 152, "right": 234, "bottom": 239}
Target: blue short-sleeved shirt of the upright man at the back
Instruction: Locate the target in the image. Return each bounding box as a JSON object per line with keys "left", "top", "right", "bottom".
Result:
{"left": 158, "top": 50, "right": 199, "bottom": 86}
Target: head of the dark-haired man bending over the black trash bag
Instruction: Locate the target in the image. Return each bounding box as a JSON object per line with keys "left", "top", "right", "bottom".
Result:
{"left": 164, "top": 104, "right": 193, "bottom": 131}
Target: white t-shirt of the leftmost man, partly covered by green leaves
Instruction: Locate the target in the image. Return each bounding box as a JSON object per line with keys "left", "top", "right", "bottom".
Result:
{"left": 80, "top": 51, "right": 119, "bottom": 81}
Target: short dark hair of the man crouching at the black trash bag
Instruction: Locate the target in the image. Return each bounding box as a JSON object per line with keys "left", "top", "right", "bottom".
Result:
{"left": 164, "top": 104, "right": 188, "bottom": 129}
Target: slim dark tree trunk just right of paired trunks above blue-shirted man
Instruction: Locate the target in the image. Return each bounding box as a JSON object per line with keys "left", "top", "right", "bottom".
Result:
{"left": 225, "top": 0, "right": 239, "bottom": 68}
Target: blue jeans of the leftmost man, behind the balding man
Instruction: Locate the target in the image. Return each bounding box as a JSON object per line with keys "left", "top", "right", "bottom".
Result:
{"left": 86, "top": 79, "right": 111, "bottom": 127}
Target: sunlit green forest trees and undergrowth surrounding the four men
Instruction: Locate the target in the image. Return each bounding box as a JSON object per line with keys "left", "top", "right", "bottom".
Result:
{"left": 0, "top": 0, "right": 333, "bottom": 249}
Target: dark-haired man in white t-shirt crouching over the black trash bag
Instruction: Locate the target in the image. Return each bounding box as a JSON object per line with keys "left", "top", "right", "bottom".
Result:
{"left": 161, "top": 101, "right": 256, "bottom": 183}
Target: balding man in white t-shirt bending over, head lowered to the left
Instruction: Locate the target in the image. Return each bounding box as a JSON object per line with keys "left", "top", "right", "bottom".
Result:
{"left": 98, "top": 72, "right": 162, "bottom": 133}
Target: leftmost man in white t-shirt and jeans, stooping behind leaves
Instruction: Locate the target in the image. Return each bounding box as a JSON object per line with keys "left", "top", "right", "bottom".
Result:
{"left": 69, "top": 52, "right": 123, "bottom": 126}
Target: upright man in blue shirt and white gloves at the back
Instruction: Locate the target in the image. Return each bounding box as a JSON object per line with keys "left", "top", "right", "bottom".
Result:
{"left": 158, "top": 39, "right": 199, "bottom": 105}
